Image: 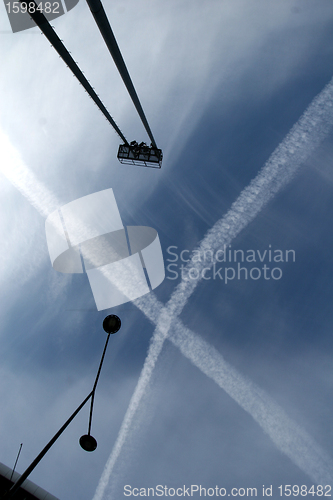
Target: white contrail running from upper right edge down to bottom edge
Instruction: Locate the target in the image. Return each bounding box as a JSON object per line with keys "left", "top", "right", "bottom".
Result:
{"left": 93, "top": 79, "right": 333, "bottom": 500}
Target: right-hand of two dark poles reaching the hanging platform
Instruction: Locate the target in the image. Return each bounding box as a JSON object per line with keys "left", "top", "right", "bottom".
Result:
{"left": 87, "top": 0, "right": 157, "bottom": 148}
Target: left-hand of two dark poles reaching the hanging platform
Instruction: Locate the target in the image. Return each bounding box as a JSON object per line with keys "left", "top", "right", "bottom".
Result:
{"left": 19, "top": 0, "right": 128, "bottom": 145}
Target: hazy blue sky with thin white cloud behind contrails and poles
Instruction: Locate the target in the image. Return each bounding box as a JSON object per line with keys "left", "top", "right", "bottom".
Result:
{"left": 0, "top": 0, "right": 333, "bottom": 500}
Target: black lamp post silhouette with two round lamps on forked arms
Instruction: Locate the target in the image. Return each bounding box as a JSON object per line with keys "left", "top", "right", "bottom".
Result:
{"left": 2, "top": 314, "right": 121, "bottom": 500}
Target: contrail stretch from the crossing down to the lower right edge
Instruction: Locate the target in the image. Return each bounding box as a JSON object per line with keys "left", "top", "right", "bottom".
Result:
{"left": 169, "top": 322, "right": 333, "bottom": 485}
